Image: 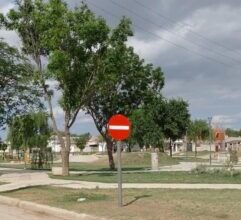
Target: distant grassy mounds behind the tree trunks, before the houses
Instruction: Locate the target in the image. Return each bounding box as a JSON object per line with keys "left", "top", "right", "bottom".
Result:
{"left": 0, "top": 153, "right": 208, "bottom": 171}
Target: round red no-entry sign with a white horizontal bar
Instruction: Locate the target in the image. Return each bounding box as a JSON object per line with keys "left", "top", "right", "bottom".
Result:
{"left": 107, "top": 114, "right": 131, "bottom": 141}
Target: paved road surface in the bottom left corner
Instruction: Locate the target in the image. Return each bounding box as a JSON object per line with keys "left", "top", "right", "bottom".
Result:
{"left": 0, "top": 204, "right": 64, "bottom": 220}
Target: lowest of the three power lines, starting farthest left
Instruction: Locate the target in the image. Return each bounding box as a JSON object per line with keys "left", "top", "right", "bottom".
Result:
{"left": 88, "top": 0, "right": 241, "bottom": 69}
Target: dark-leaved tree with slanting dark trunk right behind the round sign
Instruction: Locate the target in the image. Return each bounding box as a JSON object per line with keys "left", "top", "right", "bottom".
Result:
{"left": 85, "top": 18, "right": 164, "bottom": 169}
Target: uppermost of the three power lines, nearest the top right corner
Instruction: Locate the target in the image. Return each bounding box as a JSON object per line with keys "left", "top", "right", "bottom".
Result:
{"left": 133, "top": 0, "right": 241, "bottom": 56}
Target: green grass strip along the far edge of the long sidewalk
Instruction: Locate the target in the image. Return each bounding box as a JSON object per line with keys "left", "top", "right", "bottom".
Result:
{"left": 50, "top": 171, "right": 241, "bottom": 184}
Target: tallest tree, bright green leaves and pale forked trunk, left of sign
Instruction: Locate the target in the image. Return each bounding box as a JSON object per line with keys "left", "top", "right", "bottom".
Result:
{"left": 0, "top": 0, "right": 109, "bottom": 175}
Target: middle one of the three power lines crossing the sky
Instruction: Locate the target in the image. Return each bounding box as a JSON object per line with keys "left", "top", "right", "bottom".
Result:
{"left": 110, "top": 0, "right": 240, "bottom": 65}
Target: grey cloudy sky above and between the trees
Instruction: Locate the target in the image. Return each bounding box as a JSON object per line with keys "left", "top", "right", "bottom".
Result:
{"left": 0, "top": 0, "right": 241, "bottom": 138}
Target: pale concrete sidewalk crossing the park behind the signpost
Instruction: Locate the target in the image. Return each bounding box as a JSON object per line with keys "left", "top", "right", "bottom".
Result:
{"left": 0, "top": 173, "right": 241, "bottom": 192}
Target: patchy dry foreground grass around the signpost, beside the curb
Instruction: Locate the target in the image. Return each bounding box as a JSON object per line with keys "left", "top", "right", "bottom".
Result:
{"left": 2, "top": 187, "right": 241, "bottom": 220}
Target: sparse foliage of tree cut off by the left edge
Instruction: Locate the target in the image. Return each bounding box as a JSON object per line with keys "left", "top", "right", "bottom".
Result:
{"left": 0, "top": 40, "right": 41, "bottom": 128}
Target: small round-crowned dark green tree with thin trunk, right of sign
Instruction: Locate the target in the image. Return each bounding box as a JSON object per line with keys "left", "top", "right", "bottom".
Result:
{"left": 162, "top": 99, "right": 190, "bottom": 157}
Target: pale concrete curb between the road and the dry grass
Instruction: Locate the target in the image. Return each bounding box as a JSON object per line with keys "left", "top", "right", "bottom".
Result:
{"left": 0, "top": 196, "right": 106, "bottom": 220}
